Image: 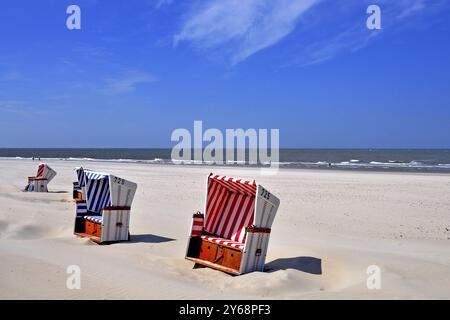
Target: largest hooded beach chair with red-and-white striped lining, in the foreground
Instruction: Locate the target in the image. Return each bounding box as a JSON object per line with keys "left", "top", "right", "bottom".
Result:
{"left": 186, "top": 174, "right": 280, "bottom": 275}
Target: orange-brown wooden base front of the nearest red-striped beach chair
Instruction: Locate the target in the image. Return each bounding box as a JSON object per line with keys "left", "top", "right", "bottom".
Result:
{"left": 186, "top": 237, "right": 242, "bottom": 275}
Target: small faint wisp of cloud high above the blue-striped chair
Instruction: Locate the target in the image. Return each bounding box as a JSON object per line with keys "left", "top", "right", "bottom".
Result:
{"left": 98, "top": 70, "right": 158, "bottom": 94}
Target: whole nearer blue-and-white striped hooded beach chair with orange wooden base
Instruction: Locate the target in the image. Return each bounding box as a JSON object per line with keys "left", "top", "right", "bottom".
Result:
{"left": 74, "top": 170, "right": 137, "bottom": 243}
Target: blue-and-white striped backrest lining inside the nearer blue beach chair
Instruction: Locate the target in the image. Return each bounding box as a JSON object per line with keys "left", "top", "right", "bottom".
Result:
{"left": 85, "top": 171, "right": 111, "bottom": 214}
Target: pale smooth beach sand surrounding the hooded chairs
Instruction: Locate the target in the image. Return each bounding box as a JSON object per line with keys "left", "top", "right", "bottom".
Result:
{"left": 0, "top": 160, "right": 450, "bottom": 299}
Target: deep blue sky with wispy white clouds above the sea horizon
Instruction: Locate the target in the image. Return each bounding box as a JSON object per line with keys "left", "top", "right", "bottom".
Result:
{"left": 0, "top": 0, "right": 450, "bottom": 148}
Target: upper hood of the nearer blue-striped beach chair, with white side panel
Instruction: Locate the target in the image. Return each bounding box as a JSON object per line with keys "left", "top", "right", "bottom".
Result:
{"left": 84, "top": 170, "right": 137, "bottom": 214}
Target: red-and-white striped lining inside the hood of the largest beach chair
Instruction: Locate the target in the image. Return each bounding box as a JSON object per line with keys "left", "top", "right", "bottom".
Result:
{"left": 205, "top": 174, "right": 256, "bottom": 243}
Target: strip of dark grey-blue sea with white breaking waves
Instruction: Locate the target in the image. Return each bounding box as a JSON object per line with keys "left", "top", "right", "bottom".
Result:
{"left": 0, "top": 148, "right": 450, "bottom": 173}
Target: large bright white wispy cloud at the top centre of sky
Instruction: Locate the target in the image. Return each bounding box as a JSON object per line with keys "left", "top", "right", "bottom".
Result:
{"left": 174, "top": 0, "right": 320, "bottom": 64}
